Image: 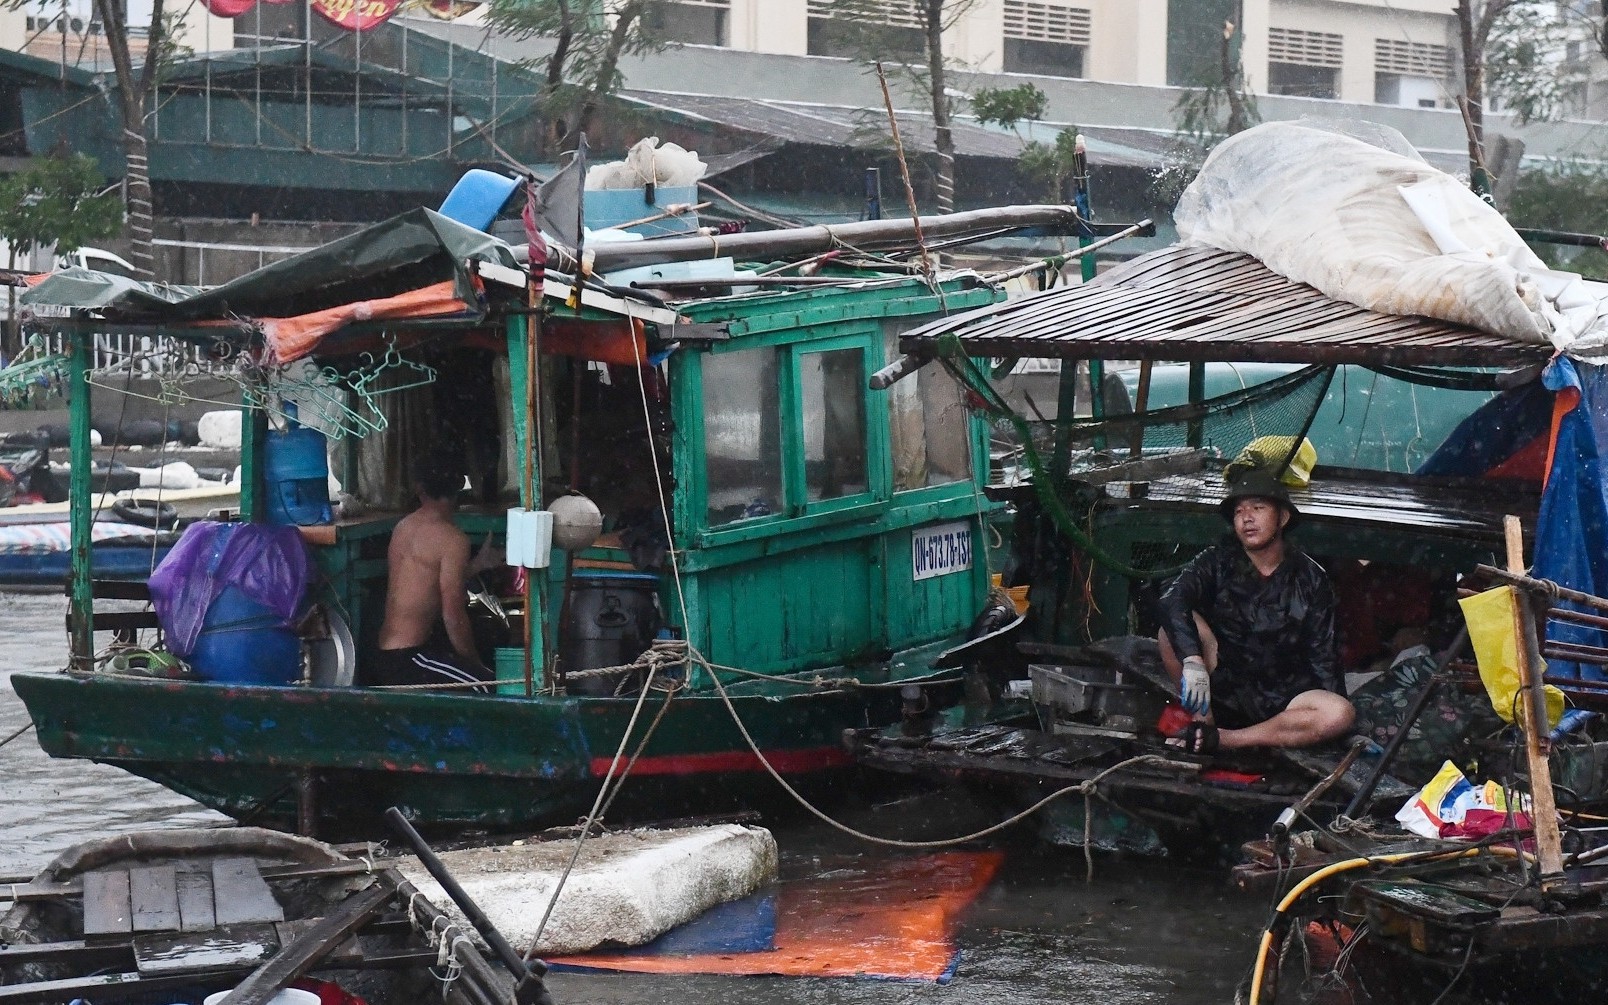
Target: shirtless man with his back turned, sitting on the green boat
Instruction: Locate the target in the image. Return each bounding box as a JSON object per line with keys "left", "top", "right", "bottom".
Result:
{"left": 367, "top": 455, "right": 497, "bottom": 695}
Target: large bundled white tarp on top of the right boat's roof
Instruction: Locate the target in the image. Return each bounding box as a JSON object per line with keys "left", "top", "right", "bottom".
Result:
{"left": 1174, "top": 121, "right": 1608, "bottom": 352}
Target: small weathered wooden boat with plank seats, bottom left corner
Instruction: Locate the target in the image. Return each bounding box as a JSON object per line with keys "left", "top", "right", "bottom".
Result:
{"left": 0, "top": 828, "right": 513, "bottom": 1005}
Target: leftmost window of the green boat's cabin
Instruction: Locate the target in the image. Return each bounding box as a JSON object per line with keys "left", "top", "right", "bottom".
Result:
{"left": 703, "top": 349, "right": 781, "bottom": 526}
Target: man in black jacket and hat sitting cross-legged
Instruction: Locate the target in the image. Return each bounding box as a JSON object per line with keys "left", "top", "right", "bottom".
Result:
{"left": 1156, "top": 470, "right": 1356, "bottom": 754}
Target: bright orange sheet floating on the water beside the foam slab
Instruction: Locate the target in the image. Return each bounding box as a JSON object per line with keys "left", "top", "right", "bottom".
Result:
{"left": 548, "top": 852, "right": 1005, "bottom": 981}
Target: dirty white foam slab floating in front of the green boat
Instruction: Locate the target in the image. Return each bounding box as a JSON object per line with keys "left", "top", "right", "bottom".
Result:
{"left": 399, "top": 823, "right": 777, "bottom": 957}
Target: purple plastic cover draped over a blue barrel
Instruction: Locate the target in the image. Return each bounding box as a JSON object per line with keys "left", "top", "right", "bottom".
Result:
{"left": 151, "top": 521, "right": 312, "bottom": 656}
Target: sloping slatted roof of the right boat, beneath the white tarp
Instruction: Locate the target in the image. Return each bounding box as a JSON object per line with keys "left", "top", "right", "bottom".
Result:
{"left": 900, "top": 246, "right": 1552, "bottom": 367}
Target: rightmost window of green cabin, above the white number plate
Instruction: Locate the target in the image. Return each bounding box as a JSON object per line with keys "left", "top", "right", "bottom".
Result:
{"left": 884, "top": 331, "right": 971, "bottom": 492}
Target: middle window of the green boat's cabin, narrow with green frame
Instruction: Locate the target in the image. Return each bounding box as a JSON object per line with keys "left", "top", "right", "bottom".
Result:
{"left": 799, "top": 349, "right": 870, "bottom": 502}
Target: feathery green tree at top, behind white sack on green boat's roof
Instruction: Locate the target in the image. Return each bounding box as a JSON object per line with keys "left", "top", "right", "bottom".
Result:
{"left": 487, "top": 0, "right": 666, "bottom": 150}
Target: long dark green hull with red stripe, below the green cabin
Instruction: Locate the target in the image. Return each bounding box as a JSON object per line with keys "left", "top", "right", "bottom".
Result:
{"left": 11, "top": 672, "right": 897, "bottom": 830}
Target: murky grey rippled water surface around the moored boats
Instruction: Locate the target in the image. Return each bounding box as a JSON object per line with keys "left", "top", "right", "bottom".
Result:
{"left": 0, "top": 593, "right": 1318, "bottom": 1005}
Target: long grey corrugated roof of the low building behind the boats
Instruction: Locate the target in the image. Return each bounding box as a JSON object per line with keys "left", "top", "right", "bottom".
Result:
{"left": 619, "top": 90, "right": 1174, "bottom": 167}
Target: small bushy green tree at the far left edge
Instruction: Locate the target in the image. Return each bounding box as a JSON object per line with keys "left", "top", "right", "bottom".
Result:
{"left": 0, "top": 154, "right": 122, "bottom": 355}
